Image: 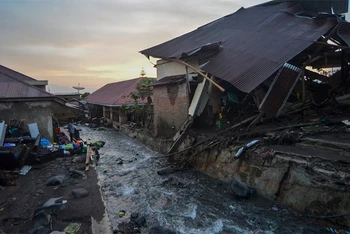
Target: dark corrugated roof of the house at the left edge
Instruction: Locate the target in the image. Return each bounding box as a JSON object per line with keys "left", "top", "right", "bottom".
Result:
{"left": 0, "top": 66, "right": 55, "bottom": 99}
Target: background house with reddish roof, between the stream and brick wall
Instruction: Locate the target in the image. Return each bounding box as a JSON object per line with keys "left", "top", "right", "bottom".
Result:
{"left": 87, "top": 77, "right": 152, "bottom": 128}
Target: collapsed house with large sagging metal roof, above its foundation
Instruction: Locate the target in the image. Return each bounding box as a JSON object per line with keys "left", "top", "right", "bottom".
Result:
{"left": 141, "top": 1, "right": 350, "bottom": 152}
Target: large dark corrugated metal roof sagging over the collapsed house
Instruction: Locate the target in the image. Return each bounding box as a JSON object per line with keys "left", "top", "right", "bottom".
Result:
{"left": 141, "top": 3, "right": 337, "bottom": 93}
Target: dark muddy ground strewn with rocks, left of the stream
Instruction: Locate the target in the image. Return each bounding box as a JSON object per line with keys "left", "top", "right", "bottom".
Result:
{"left": 0, "top": 152, "right": 105, "bottom": 234}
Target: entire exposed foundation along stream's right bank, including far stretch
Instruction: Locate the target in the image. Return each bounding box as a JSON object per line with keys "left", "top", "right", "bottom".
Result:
{"left": 122, "top": 128, "right": 350, "bottom": 226}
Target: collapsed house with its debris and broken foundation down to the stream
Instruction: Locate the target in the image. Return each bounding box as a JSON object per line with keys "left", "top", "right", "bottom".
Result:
{"left": 141, "top": 1, "right": 350, "bottom": 226}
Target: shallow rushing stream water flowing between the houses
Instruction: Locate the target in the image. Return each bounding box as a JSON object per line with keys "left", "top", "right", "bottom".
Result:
{"left": 81, "top": 128, "right": 325, "bottom": 234}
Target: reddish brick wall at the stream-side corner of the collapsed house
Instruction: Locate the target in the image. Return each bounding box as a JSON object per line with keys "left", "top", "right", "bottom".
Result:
{"left": 153, "top": 83, "right": 190, "bottom": 138}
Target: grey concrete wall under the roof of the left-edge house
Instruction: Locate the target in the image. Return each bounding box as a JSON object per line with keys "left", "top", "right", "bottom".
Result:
{"left": 0, "top": 101, "right": 53, "bottom": 141}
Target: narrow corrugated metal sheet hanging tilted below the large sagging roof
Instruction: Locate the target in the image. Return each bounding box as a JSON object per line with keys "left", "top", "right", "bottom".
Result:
{"left": 259, "top": 64, "right": 301, "bottom": 117}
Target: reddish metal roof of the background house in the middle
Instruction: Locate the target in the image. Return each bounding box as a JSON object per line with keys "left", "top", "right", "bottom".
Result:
{"left": 87, "top": 78, "right": 147, "bottom": 106}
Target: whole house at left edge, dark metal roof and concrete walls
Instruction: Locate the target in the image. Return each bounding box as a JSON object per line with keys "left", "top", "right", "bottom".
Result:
{"left": 0, "top": 66, "right": 78, "bottom": 141}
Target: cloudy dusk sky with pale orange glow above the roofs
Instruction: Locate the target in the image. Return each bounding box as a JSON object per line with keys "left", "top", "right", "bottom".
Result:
{"left": 0, "top": 0, "right": 348, "bottom": 93}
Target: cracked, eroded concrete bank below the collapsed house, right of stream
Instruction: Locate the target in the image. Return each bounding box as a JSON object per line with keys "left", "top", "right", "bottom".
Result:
{"left": 193, "top": 146, "right": 350, "bottom": 226}
